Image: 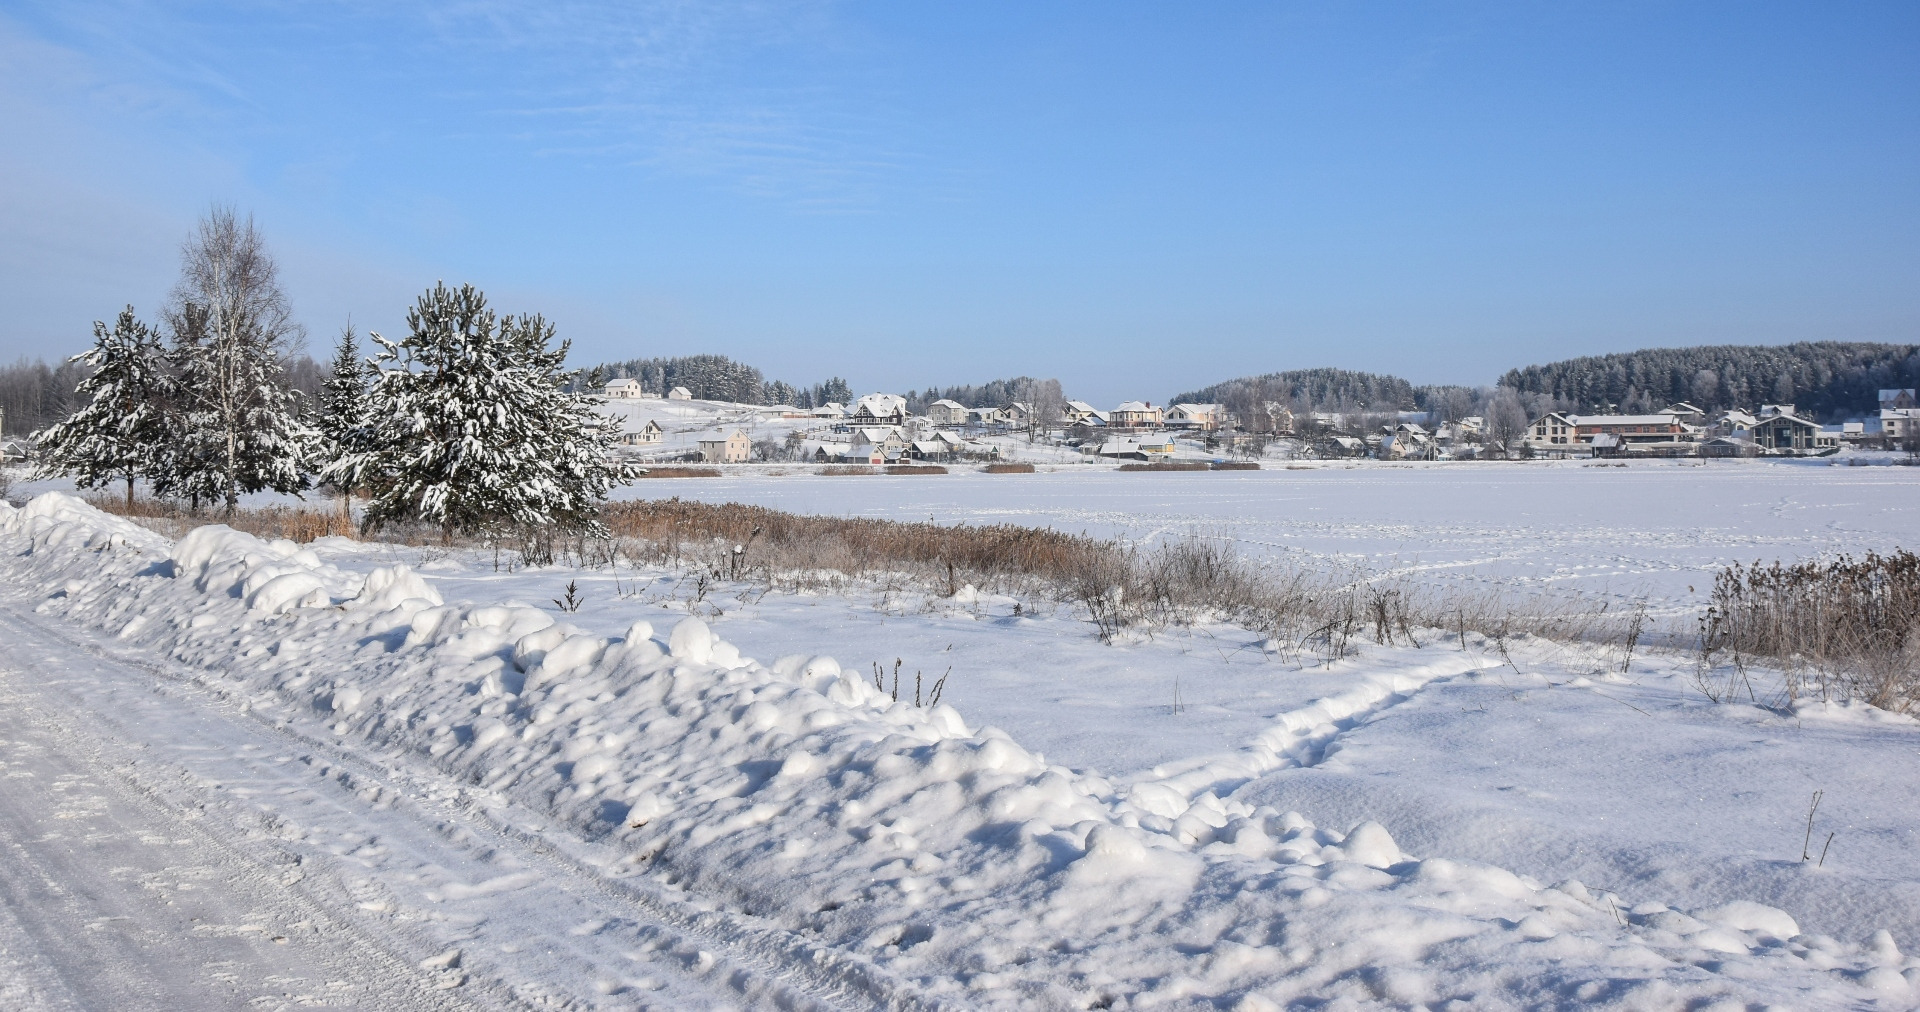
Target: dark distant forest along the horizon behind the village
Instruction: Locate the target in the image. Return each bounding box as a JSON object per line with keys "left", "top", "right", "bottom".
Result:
{"left": 0, "top": 342, "right": 1920, "bottom": 434}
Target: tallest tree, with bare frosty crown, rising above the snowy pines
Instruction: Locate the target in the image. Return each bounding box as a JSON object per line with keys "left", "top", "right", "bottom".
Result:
{"left": 154, "top": 207, "right": 313, "bottom": 513}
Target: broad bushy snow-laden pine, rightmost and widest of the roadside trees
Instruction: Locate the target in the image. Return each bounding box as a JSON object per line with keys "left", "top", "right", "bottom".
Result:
{"left": 321, "top": 284, "right": 634, "bottom": 540}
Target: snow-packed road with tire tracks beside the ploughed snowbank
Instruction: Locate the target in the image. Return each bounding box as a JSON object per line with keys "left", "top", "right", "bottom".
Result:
{"left": 0, "top": 605, "right": 856, "bottom": 1010}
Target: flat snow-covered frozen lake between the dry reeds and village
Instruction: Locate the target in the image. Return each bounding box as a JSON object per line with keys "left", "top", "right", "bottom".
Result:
{"left": 622, "top": 461, "right": 1920, "bottom": 609}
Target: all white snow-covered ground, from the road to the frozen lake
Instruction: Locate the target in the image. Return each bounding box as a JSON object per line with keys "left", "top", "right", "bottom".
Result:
{"left": 0, "top": 463, "right": 1920, "bottom": 1008}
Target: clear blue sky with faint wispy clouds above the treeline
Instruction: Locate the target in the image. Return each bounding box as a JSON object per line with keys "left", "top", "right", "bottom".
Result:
{"left": 0, "top": 0, "right": 1920, "bottom": 401}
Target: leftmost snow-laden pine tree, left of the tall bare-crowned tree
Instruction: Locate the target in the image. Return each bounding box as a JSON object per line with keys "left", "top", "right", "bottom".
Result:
{"left": 36, "top": 305, "right": 167, "bottom": 513}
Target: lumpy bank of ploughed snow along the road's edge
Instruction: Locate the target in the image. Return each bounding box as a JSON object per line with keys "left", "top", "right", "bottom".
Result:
{"left": 0, "top": 494, "right": 1920, "bottom": 1008}
